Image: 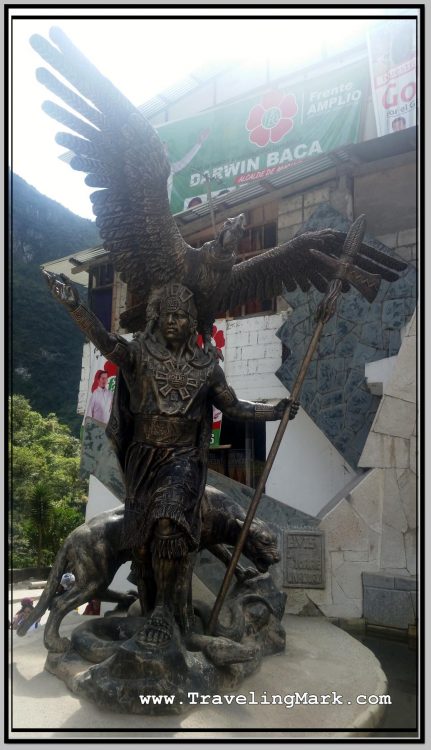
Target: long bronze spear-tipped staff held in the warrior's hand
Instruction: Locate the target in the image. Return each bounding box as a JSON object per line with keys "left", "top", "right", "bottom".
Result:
{"left": 208, "top": 214, "right": 372, "bottom": 634}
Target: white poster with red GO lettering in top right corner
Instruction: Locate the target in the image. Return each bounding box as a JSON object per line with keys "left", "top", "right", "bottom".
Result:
{"left": 368, "top": 19, "right": 417, "bottom": 136}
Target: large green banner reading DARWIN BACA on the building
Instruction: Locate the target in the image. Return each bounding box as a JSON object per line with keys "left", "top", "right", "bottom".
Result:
{"left": 157, "top": 59, "right": 369, "bottom": 213}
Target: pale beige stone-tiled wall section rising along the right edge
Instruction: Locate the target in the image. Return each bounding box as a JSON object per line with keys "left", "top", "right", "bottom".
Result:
{"left": 288, "top": 315, "right": 417, "bottom": 628}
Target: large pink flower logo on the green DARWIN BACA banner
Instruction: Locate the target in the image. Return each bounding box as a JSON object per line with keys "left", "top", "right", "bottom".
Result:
{"left": 246, "top": 91, "right": 298, "bottom": 148}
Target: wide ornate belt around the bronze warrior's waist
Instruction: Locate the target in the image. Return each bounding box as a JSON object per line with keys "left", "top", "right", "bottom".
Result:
{"left": 133, "top": 415, "right": 198, "bottom": 448}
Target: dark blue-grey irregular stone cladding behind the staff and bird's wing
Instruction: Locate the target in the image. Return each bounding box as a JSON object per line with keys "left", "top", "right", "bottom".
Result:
{"left": 277, "top": 200, "right": 416, "bottom": 468}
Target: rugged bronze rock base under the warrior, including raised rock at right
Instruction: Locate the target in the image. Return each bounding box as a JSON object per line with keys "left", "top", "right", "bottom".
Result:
{"left": 45, "top": 573, "right": 286, "bottom": 715}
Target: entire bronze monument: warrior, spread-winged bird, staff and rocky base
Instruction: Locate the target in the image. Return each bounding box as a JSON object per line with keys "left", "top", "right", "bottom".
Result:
{"left": 27, "top": 29, "right": 405, "bottom": 712}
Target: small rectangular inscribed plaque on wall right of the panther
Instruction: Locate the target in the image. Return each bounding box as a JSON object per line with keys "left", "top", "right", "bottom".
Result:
{"left": 283, "top": 529, "right": 325, "bottom": 589}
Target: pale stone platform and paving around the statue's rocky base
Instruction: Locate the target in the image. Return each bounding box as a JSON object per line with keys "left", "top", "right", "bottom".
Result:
{"left": 11, "top": 581, "right": 387, "bottom": 741}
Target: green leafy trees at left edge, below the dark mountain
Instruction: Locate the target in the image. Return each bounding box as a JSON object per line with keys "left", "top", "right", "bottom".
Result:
{"left": 9, "top": 395, "right": 87, "bottom": 567}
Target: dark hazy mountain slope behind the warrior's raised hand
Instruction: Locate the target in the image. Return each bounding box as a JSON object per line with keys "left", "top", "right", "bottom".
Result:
{"left": 10, "top": 175, "right": 100, "bottom": 435}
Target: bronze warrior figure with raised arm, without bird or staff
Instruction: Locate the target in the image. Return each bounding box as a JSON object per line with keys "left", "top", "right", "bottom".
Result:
{"left": 45, "top": 272, "right": 298, "bottom": 643}
